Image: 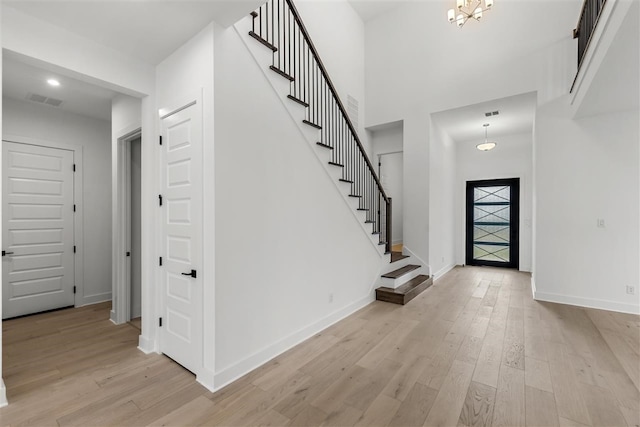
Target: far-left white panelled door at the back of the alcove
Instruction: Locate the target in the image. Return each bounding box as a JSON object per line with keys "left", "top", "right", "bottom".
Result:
{"left": 2, "top": 141, "right": 74, "bottom": 319}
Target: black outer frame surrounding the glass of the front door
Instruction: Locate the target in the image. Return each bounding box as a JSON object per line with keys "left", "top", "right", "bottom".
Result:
{"left": 463, "top": 177, "right": 521, "bottom": 270}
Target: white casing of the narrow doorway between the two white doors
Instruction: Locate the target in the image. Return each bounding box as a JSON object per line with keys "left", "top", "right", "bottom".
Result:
{"left": 111, "top": 126, "right": 143, "bottom": 324}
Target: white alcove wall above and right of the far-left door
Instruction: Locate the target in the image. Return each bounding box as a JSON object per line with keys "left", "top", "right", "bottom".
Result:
{"left": 2, "top": 98, "right": 111, "bottom": 303}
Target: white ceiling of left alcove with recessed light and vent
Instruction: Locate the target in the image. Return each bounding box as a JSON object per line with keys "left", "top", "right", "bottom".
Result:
{"left": 2, "top": 54, "right": 116, "bottom": 120}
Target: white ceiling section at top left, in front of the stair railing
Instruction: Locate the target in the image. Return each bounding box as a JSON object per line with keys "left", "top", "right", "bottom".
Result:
{"left": 3, "top": 0, "right": 263, "bottom": 65}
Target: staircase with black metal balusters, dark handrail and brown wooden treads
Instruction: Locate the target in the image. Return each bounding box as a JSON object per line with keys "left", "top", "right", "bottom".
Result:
{"left": 244, "top": 0, "right": 432, "bottom": 304}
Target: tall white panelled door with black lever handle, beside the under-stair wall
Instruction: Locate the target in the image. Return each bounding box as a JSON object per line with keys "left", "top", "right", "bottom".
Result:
{"left": 160, "top": 105, "right": 203, "bottom": 374}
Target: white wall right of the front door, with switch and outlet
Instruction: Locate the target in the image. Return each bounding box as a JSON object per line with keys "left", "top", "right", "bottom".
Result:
{"left": 534, "top": 98, "right": 640, "bottom": 314}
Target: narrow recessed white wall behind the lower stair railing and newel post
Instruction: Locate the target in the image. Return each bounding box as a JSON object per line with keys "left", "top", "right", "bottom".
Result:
{"left": 369, "top": 123, "right": 404, "bottom": 244}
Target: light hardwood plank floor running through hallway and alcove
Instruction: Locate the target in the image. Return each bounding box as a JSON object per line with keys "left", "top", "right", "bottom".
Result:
{"left": 0, "top": 267, "right": 640, "bottom": 426}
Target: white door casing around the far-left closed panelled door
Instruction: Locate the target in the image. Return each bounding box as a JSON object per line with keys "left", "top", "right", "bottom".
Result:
{"left": 0, "top": 135, "right": 84, "bottom": 308}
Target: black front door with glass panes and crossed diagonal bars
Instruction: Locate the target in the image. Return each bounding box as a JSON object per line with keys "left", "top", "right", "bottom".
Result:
{"left": 466, "top": 178, "right": 520, "bottom": 268}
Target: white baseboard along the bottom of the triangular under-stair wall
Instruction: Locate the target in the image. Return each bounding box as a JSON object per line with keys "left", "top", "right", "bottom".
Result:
{"left": 214, "top": 292, "right": 375, "bottom": 390}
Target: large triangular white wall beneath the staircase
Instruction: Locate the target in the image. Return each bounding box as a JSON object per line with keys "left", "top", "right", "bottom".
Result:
{"left": 215, "top": 15, "right": 381, "bottom": 387}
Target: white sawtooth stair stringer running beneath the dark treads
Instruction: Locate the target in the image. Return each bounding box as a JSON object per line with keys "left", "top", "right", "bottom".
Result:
{"left": 233, "top": 16, "right": 384, "bottom": 258}
